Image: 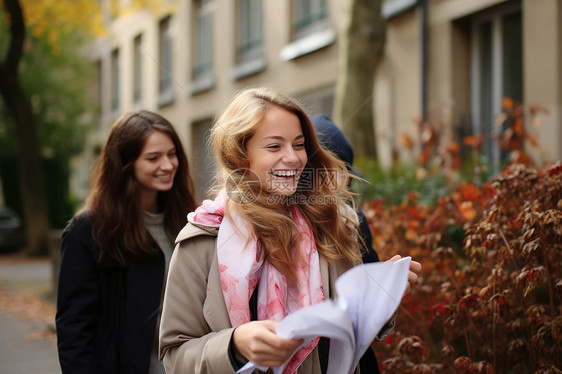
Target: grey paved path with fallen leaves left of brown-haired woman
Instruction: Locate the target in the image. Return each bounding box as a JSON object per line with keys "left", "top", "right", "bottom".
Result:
{"left": 0, "top": 255, "right": 61, "bottom": 374}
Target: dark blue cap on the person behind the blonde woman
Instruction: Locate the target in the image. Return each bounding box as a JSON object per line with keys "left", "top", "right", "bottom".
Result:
{"left": 310, "top": 114, "right": 363, "bottom": 178}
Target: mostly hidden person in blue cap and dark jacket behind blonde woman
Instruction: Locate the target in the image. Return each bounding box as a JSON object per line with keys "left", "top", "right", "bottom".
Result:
{"left": 310, "top": 114, "right": 379, "bottom": 373}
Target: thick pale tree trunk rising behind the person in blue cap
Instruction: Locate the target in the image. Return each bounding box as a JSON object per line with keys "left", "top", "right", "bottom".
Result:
{"left": 333, "top": 0, "right": 385, "bottom": 158}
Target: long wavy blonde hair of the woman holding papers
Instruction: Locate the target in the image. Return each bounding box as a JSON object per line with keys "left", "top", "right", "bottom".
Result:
{"left": 210, "top": 87, "right": 361, "bottom": 278}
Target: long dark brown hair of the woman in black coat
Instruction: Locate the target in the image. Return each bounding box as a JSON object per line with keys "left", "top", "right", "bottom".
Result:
{"left": 82, "top": 110, "right": 196, "bottom": 265}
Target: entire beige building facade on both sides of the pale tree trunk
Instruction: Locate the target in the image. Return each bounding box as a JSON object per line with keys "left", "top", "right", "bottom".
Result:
{"left": 79, "top": 0, "right": 562, "bottom": 199}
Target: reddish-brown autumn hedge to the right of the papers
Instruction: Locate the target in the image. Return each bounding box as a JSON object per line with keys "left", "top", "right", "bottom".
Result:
{"left": 366, "top": 101, "right": 562, "bottom": 373}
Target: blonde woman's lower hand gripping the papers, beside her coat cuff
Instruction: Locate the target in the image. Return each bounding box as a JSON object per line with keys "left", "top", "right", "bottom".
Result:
{"left": 232, "top": 321, "right": 303, "bottom": 367}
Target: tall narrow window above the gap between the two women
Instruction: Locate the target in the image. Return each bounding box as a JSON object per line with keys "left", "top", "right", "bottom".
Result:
{"left": 193, "top": 0, "right": 213, "bottom": 79}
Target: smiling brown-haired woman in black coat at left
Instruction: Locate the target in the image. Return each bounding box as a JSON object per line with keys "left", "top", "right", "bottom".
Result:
{"left": 56, "top": 110, "right": 196, "bottom": 374}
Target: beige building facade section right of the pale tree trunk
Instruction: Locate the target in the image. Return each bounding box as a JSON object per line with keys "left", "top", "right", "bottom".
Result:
{"left": 374, "top": 0, "right": 562, "bottom": 168}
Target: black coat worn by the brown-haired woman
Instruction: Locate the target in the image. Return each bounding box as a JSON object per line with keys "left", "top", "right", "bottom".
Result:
{"left": 56, "top": 215, "right": 165, "bottom": 374}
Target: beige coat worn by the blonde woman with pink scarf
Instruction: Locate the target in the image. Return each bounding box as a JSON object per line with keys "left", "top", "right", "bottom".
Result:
{"left": 160, "top": 223, "right": 359, "bottom": 374}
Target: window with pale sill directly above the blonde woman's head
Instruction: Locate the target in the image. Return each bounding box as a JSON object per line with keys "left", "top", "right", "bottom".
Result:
{"left": 233, "top": 0, "right": 266, "bottom": 79}
